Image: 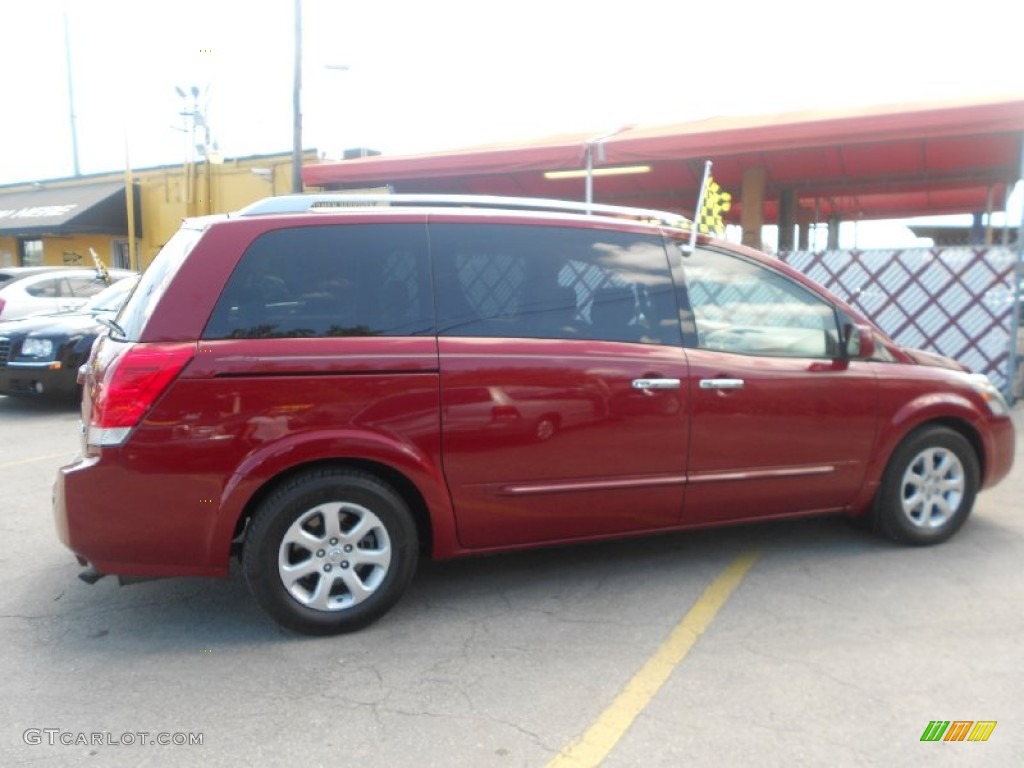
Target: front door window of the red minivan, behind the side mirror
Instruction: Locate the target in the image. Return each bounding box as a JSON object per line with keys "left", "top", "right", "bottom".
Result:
{"left": 683, "top": 249, "right": 840, "bottom": 357}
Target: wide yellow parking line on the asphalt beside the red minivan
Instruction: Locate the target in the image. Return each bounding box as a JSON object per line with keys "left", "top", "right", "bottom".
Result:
{"left": 547, "top": 552, "right": 758, "bottom": 768}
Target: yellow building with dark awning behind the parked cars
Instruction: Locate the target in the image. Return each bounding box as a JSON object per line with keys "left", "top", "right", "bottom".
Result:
{"left": 0, "top": 151, "right": 316, "bottom": 269}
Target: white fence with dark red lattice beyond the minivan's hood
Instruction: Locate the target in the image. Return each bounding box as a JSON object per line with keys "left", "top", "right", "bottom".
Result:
{"left": 779, "top": 248, "right": 1017, "bottom": 397}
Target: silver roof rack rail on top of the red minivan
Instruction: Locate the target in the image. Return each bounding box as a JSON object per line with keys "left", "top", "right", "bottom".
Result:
{"left": 234, "top": 193, "right": 692, "bottom": 229}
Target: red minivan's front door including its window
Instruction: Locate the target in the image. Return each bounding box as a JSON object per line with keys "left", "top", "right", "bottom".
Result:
{"left": 676, "top": 248, "right": 878, "bottom": 522}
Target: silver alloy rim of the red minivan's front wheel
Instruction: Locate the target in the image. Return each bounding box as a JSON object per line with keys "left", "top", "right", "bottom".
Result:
{"left": 900, "top": 446, "right": 967, "bottom": 528}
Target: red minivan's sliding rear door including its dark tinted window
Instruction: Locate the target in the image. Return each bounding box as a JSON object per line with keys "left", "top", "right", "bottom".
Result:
{"left": 430, "top": 220, "right": 688, "bottom": 548}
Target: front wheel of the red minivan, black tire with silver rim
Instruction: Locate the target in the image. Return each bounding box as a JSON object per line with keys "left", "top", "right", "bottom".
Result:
{"left": 872, "top": 427, "right": 980, "bottom": 545}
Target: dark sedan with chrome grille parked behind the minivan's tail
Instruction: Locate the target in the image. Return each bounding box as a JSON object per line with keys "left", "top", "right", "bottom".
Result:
{"left": 0, "top": 276, "right": 138, "bottom": 397}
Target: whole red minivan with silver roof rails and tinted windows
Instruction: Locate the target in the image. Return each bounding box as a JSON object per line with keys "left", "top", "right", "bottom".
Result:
{"left": 54, "top": 196, "right": 1014, "bottom": 634}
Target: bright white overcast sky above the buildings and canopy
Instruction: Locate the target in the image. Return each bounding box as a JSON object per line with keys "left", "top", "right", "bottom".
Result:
{"left": 0, "top": 0, "right": 1024, "bottom": 244}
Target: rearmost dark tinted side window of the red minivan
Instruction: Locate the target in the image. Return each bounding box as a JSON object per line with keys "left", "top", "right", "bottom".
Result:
{"left": 203, "top": 224, "right": 434, "bottom": 339}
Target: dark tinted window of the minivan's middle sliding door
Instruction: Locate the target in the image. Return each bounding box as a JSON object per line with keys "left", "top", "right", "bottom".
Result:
{"left": 430, "top": 224, "right": 682, "bottom": 345}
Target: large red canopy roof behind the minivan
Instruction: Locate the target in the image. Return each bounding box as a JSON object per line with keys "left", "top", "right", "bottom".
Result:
{"left": 303, "top": 99, "right": 1024, "bottom": 221}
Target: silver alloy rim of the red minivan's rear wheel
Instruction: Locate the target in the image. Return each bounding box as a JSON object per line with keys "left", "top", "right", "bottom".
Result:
{"left": 278, "top": 502, "right": 391, "bottom": 611}
